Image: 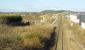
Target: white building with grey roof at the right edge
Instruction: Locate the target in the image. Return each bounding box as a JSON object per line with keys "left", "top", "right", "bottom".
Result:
{"left": 66, "top": 13, "right": 85, "bottom": 29}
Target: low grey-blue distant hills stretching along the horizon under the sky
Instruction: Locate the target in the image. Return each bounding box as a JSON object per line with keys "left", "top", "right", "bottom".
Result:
{"left": 0, "top": 10, "right": 85, "bottom": 15}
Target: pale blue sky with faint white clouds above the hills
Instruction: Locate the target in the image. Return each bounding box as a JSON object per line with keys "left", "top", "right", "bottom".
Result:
{"left": 0, "top": 0, "right": 85, "bottom": 12}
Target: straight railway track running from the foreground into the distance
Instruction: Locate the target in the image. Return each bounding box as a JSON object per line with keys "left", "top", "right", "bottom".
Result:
{"left": 53, "top": 14, "right": 64, "bottom": 50}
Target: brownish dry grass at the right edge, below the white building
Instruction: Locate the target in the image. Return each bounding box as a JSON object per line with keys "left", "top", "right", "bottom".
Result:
{"left": 71, "top": 24, "right": 85, "bottom": 46}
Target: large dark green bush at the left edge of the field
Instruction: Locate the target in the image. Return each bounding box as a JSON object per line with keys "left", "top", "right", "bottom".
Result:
{"left": 0, "top": 15, "right": 22, "bottom": 24}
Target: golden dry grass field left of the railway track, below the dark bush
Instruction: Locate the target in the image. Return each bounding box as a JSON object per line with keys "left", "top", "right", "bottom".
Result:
{"left": 0, "top": 24, "right": 53, "bottom": 50}
